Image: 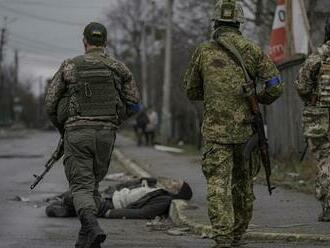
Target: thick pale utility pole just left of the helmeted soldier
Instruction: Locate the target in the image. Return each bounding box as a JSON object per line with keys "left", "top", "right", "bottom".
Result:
{"left": 161, "top": 0, "right": 174, "bottom": 144}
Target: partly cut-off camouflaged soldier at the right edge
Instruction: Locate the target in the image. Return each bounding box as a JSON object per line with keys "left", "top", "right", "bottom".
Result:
{"left": 295, "top": 22, "right": 330, "bottom": 221}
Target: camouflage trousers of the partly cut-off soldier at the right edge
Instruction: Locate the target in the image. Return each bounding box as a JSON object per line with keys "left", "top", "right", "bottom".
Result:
{"left": 303, "top": 106, "right": 330, "bottom": 210}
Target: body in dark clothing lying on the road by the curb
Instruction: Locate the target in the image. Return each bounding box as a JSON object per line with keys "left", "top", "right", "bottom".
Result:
{"left": 46, "top": 178, "right": 192, "bottom": 219}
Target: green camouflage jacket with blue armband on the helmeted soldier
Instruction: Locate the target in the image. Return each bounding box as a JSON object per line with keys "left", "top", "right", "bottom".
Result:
{"left": 184, "top": 28, "right": 283, "bottom": 144}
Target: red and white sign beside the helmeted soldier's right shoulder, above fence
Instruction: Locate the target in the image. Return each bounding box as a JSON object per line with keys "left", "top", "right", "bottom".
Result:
{"left": 269, "top": 0, "right": 287, "bottom": 63}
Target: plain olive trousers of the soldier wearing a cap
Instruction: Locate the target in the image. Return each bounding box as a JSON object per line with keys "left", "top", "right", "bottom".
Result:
{"left": 64, "top": 128, "right": 116, "bottom": 215}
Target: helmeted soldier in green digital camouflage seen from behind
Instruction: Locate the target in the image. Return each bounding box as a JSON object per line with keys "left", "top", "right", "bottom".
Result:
{"left": 184, "top": 0, "right": 282, "bottom": 247}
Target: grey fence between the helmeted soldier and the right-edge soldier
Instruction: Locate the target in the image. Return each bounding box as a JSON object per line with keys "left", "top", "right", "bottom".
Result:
{"left": 266, "top": 55, "right": 305, "bottom": 158}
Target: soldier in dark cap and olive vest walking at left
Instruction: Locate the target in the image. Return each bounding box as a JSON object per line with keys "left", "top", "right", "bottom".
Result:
{"left": 46, "top": 23, "right": 140, "bottom": 248}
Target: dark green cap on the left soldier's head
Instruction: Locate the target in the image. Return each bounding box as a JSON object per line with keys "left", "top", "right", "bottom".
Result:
{"left": 84, "top": 22, "right": 107, "bottom": 46}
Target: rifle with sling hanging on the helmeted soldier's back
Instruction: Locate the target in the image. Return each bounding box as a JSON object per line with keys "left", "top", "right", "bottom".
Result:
{"left": 218, "top": 39, "right": 275, "bottom": 195}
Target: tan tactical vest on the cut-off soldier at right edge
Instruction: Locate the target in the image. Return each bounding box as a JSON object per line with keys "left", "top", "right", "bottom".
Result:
{"left": 318, "top": 58, "right": 330, "bottom": 108}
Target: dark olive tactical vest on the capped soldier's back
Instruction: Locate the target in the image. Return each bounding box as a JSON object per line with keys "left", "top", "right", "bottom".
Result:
{"left": 68, "top": 60, "right": 118, "bottom": 120}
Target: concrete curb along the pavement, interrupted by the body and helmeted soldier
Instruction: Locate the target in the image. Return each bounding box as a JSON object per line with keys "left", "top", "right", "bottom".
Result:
{"left": 113, "top": 149, "right": 330, "bottom": 243}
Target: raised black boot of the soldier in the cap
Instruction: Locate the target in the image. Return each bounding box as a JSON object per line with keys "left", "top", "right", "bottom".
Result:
{"left": 78, "top": 210, "right": 106, "bottom": 248}
